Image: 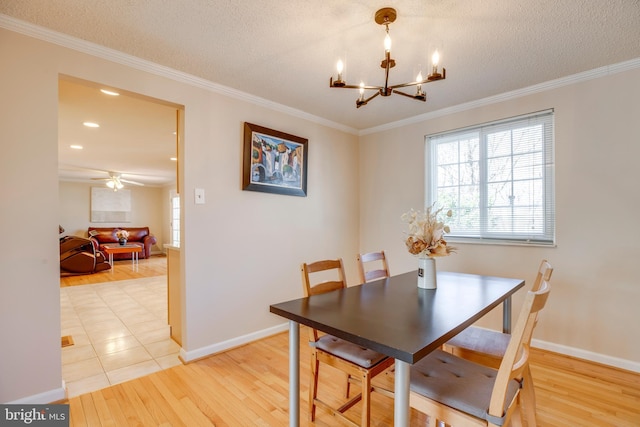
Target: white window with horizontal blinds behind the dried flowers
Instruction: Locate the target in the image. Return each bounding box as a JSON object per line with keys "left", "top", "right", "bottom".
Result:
{"left": 425, "top": 109, "right": 555, "bottom": 246}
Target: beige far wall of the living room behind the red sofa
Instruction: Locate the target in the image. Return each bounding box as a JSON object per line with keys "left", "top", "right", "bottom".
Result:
{"left": 58, "top": 181, "right": 169, "bottom": 253}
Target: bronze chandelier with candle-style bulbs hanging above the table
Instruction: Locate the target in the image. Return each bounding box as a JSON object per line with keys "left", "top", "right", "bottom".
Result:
{"left": 329, "top": 7, "right": 446, "bottom": 108}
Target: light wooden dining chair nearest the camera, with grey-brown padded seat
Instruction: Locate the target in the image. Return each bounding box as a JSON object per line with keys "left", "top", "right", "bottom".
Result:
{"left": 409, "top": 280, "right": 549, "bottom": 427}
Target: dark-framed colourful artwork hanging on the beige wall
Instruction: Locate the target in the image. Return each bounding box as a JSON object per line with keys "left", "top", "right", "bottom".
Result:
{"left": 242, "top": 122, "right": 309, "bottom": 197}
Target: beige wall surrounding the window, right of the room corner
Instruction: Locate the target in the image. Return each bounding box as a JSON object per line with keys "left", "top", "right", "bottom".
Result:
{"left": 360, "top": 64, "right": 640, "bottom": 371}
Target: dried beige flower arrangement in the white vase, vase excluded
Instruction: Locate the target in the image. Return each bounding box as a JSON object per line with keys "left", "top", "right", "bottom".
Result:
{"left": 401, "top": 206, "right": 456, "bottom": 258}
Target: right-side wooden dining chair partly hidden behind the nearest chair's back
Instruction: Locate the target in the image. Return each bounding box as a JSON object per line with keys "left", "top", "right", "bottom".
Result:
{"left": 443, "top": 259, "right": 553, "bottom": 425}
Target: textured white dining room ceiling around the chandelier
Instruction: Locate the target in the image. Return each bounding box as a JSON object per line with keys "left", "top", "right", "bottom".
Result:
{"left": 0, "top": 0, "right": 640, "bottom": 185}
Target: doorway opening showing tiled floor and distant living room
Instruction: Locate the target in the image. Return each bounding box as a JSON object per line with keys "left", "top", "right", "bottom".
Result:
{"left": 58, "top": 76, "right": 183, "bottom": 397}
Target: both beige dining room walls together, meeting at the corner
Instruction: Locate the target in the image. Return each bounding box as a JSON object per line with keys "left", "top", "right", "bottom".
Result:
{"left": 0, "top": 22, "right": 640, "bottom": 403}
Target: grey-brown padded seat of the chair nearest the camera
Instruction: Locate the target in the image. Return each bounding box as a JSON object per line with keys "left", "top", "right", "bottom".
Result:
{"left": 411, "top": 350, "right": 520, "bottom": 425}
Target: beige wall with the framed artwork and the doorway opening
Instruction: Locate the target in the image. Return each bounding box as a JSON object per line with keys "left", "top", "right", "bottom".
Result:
{"left": 0, "top": 29, "right": 359, "bottom": 403}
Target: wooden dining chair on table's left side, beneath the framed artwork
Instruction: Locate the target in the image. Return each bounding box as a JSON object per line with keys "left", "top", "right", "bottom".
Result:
{"left": 301, "top": 259, "right": 394, "bottom": 427}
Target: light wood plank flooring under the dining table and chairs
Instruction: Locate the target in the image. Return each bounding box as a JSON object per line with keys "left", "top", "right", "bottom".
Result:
{"left": 69, "top": 331, "right": 640, "bottom": 427}
